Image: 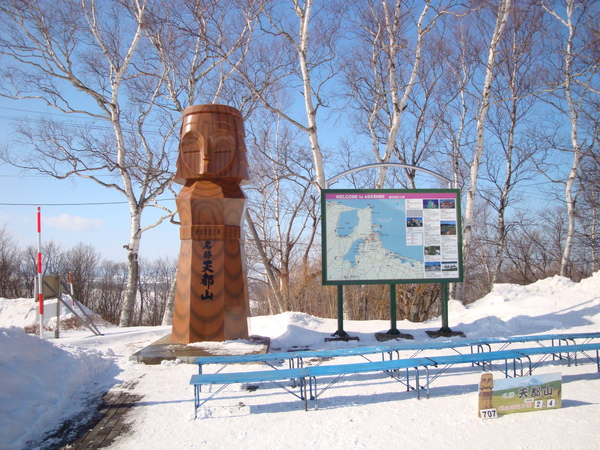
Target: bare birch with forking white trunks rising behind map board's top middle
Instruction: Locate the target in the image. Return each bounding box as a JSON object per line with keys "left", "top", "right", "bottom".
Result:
{"left": 345, "top": 0, "right": 454, "bottom": 189}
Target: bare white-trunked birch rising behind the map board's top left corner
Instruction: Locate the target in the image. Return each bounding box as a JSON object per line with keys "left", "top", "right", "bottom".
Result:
{"left": 233, "top": 0, "right": 340, "bottom": 189}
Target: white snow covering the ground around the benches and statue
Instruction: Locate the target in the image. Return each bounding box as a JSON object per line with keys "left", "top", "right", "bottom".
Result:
{"left": 0, "top": 273, "right": 600, "bottom": 449}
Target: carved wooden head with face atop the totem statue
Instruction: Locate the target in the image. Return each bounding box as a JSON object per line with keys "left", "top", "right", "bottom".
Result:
{"left": 175, "top": 104, "right": 248, "bottom": 184}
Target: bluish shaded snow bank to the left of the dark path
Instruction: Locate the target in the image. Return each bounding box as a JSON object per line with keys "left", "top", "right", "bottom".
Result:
{"left": 0, "top": 327, "right": 117, "bottom": 449}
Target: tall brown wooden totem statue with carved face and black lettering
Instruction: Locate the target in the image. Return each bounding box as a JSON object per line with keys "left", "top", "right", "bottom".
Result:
{"left": 171, "top": 104, "right": 249, "bottom": 344}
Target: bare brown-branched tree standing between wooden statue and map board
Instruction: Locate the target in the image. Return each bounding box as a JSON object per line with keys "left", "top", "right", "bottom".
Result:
{"left": 247, "top": 105, "right": 320, "bottom": 313}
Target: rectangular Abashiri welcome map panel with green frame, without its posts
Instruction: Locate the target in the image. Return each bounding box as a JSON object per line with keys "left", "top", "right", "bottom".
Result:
{"left": 321, "top": 189, "right": 462, "bottom": 284}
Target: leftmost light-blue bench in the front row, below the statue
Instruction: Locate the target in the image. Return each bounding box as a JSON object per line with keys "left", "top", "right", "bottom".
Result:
{"left": 190, "top": 369, "right": 308, "bottom": 419}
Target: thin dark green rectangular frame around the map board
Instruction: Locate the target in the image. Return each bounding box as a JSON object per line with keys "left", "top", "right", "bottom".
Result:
{"left": 321, "top": 189, "right": 463, "bottom": 285}
